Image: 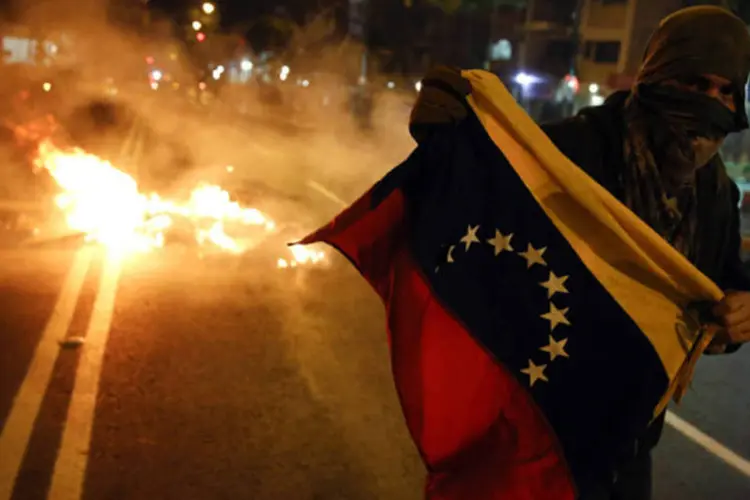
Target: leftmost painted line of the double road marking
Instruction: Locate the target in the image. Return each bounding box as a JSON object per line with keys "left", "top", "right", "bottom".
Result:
{"left": 0, "top": 248, "right": 93, "bottom": 500}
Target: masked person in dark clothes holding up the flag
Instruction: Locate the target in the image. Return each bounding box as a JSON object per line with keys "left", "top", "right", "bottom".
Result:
{"left": 410, "top": 6, "right": 750, "bottom": 500}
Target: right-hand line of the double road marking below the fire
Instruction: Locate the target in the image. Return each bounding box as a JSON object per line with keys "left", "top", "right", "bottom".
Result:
{"left": 47, "top": 253, "right": 122, "bottom": 500}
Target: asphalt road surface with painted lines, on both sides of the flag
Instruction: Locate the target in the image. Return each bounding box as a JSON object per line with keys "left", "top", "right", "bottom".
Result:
{"left": 0, "top": 110, "right": 750, "bottom": 500}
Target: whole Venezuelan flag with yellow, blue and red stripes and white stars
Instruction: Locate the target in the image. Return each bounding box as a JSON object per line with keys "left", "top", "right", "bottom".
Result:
{"left": 302, "top": 71, "right": 722, "bottom": 500}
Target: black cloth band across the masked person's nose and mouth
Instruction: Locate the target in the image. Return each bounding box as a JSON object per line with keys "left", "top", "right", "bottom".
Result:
{"left": 636, "top": 84, "right": 745, "bottom": 139}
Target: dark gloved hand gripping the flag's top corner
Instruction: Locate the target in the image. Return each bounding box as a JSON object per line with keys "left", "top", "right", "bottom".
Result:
{"left": 409, "top": 66, "right": 471, "bottom": 143}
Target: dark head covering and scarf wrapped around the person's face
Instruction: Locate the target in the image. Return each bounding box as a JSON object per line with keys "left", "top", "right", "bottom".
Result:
{"left": 623, "top": 6, "right": 750, "bottom": 262}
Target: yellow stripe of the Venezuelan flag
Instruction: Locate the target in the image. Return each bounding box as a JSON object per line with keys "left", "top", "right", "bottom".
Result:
{"left": 463, "top": 70, "right": 723, "bottom": 415}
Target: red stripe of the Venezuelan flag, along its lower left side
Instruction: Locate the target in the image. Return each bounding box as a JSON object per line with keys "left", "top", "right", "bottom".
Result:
{"left": 304, "top": 190, "right": 575, "bottom": 500}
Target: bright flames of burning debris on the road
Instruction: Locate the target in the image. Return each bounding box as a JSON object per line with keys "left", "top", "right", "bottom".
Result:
{"left": 26, "top": 139, "right": 324, "bottom": 268}
